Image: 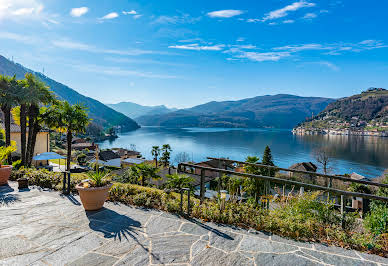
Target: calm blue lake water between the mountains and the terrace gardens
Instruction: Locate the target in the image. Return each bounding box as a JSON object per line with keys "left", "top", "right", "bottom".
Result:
{"left": 100, "top": 127, "right": 388, "bottom": 178}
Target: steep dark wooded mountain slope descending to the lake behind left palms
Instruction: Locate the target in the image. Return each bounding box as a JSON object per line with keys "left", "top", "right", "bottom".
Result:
{"left": 0, "top": 55, "right": 139, "bottom": 131}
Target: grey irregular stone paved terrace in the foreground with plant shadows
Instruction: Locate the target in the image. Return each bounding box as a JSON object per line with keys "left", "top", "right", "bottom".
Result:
{"left": 0, "top": 183, "right": 388, "bottom": 265}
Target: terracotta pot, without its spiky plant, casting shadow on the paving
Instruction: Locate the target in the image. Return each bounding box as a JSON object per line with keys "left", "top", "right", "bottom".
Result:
{"left": 75, "top": 184, "right": 112, "bottom": 211}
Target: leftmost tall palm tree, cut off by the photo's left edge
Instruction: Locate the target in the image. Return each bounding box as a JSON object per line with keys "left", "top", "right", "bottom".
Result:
{"left": 0, "top": 76, "right": 17, "bottom": 162}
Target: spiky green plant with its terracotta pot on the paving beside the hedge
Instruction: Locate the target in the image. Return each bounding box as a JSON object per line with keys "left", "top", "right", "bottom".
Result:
{"left": 75, "top": 171, "right": 112, "bottom": 211}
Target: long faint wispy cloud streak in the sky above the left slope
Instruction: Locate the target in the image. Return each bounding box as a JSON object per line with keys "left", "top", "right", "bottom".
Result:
{"left": 52, "top": 39, "right": 156, "bottom": 56}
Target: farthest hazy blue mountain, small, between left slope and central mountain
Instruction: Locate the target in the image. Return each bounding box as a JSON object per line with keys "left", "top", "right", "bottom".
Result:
{"left": 107, "top": 102, "right": 177, "bottom": 119}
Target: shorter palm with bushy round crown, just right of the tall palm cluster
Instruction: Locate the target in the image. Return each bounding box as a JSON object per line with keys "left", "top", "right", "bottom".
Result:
{"left": 46, "top": 101, "right": 90, "bottom": 171}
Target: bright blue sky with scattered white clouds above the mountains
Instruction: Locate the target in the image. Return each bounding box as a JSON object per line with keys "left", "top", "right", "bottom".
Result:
{"left": 0, "top": 0, "right": 388, "bottom": 107}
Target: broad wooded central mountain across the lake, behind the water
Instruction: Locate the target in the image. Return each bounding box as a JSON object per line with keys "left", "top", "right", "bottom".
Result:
{"left": 136, "top": 94, "right": 334, "bottom": 128}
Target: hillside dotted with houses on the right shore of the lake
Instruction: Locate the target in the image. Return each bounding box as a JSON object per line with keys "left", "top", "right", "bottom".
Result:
{"left": 296, "top": 88, "right": 388, "bottom": 133}
